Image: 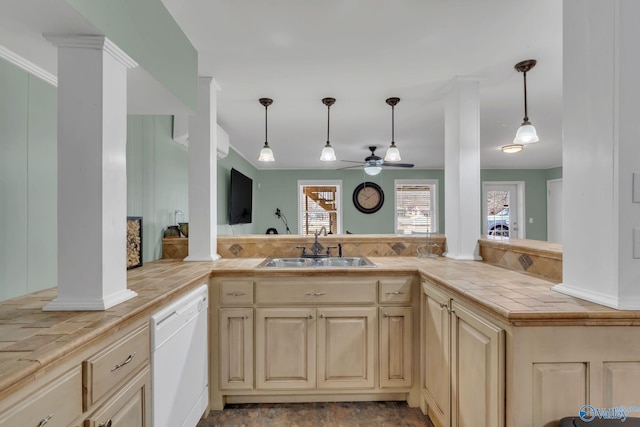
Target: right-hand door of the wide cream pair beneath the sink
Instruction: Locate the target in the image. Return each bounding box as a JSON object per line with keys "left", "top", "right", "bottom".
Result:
{"left": 318, "top": 307, "right": 376, "bottom": 388}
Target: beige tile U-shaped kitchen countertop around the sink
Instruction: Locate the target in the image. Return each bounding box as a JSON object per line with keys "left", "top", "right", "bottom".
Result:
{"left": 0, "top": 257, "right": 640, "bottom": 402}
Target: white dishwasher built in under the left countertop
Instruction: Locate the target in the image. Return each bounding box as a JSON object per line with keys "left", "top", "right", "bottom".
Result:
{"left": 150, "top": 285, "right": 209, "bottom": 427}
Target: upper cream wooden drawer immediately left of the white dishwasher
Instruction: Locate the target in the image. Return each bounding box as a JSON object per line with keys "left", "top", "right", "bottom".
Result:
{"left": 82, "top": 325, "right": 149, "bottom": 411}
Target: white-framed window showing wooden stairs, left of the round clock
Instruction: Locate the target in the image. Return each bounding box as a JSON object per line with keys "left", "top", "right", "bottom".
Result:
{"left": 298, "top": 181, "right": 342, "bottom": 235}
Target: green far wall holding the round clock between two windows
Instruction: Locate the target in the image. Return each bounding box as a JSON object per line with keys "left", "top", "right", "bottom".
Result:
{"left": 256, "top": 169, "right": 444, "bottom": 234}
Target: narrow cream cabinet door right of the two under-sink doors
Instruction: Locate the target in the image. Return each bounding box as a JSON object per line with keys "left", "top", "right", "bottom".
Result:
{"left": 380, "top": 307, "right": 413, "bottom": 388}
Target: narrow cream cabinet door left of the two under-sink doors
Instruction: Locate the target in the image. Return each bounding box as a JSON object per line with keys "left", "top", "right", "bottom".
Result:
{"left": 219, "top": 308, "right": 253, "bottom": 390}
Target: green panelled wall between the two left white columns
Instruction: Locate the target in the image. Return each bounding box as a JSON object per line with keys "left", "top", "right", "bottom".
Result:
{"left": 127, "top": 116, "right": 189, "bottom": 262}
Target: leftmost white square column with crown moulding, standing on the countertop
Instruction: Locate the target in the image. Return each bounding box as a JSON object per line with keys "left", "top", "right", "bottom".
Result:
{"left": 43, "top": 35, "right": 137, "bottom": 311}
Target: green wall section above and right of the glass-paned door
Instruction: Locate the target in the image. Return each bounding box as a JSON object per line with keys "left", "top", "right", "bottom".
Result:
{"left": 480, "top": 168, "right": 562, "bottom": 240}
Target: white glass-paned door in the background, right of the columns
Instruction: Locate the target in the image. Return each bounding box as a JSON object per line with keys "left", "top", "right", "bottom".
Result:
{"left": 482, "top": 182, "right": 524, "bottom": 239}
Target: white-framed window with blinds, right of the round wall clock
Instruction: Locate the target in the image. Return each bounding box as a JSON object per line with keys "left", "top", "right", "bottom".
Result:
{"left": 395, "top": 179, "right": 438, "bottom": 234}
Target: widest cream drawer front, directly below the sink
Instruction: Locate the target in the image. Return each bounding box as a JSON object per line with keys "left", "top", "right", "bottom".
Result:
{"left": 256, "top": 278, "right": 378, "bottom": 305}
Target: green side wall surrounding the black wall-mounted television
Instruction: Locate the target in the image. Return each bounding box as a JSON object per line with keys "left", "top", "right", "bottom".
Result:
{"left": 217, "top": 147, "right": 264, "bottom": 235}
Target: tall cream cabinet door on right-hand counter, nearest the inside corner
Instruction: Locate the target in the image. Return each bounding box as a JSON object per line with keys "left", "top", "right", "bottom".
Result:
{"left": 421, "top": 285, "right": 451, "bottom": 427}
